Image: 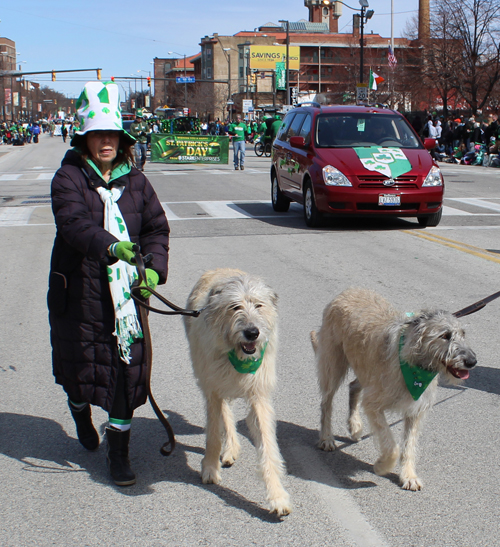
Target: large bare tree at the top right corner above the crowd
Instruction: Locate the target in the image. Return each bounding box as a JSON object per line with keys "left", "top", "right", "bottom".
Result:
{"left": 442, "top": 0, "right": 500, "bottom": 114}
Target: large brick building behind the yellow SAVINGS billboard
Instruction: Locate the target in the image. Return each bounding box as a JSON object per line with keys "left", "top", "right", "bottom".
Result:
{"left": 155, "top": 0, "right": 422, "bottom": 119}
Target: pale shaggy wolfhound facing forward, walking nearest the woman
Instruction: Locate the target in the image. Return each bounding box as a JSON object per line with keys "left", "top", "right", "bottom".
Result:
{"left": 184, "top": 269, "right": 291, "bottom": 516}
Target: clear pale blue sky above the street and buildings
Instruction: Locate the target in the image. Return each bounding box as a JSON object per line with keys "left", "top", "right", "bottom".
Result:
{"left": 0, "top": 0, "right": 418, "bottom": 96}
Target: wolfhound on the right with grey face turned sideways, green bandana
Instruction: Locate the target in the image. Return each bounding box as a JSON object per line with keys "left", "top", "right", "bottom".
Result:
{"left": 311, "top": 288, "right": 476, "bottom": 490}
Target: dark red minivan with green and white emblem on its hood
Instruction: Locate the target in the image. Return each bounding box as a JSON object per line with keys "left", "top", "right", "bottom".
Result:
{"left": 271, "top": 103, "right": 444, "bottom": 226}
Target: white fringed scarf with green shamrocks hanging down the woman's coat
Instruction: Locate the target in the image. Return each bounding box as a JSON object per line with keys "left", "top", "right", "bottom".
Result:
{"left": 97, "top": 186, "right": 143, "bottom": 364}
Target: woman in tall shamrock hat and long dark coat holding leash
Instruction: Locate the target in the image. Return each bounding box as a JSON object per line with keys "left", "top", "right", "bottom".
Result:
{"left": 48, "top": 82, "right": 169, "bottom": 486}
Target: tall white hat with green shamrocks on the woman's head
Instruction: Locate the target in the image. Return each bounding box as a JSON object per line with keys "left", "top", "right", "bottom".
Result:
{"left": 71, "top": 82, "right": 135, "bottom": 146}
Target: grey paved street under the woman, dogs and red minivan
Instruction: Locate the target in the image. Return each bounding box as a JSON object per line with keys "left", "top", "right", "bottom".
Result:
{"left": 0, "top": 137, "right": 500, "bottom": 547}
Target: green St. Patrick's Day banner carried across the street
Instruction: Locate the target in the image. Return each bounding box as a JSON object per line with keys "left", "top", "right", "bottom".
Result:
{"left": 151, "top": 133, "right": 229, "bottom": 165}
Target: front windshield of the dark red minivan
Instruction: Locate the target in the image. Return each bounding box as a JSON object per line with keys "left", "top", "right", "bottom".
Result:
{"left": 315, "top": 113, "right": 423, "bottom": 148}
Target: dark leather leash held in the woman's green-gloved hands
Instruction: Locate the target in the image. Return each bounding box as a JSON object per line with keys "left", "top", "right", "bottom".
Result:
{"left": 130, "top": 245, "right": 202, "bottom": 456}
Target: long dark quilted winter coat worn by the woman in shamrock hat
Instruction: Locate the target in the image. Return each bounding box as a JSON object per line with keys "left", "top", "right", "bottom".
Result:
{"left": 48, "top": 150, "right": 170, "bottom": 412}
